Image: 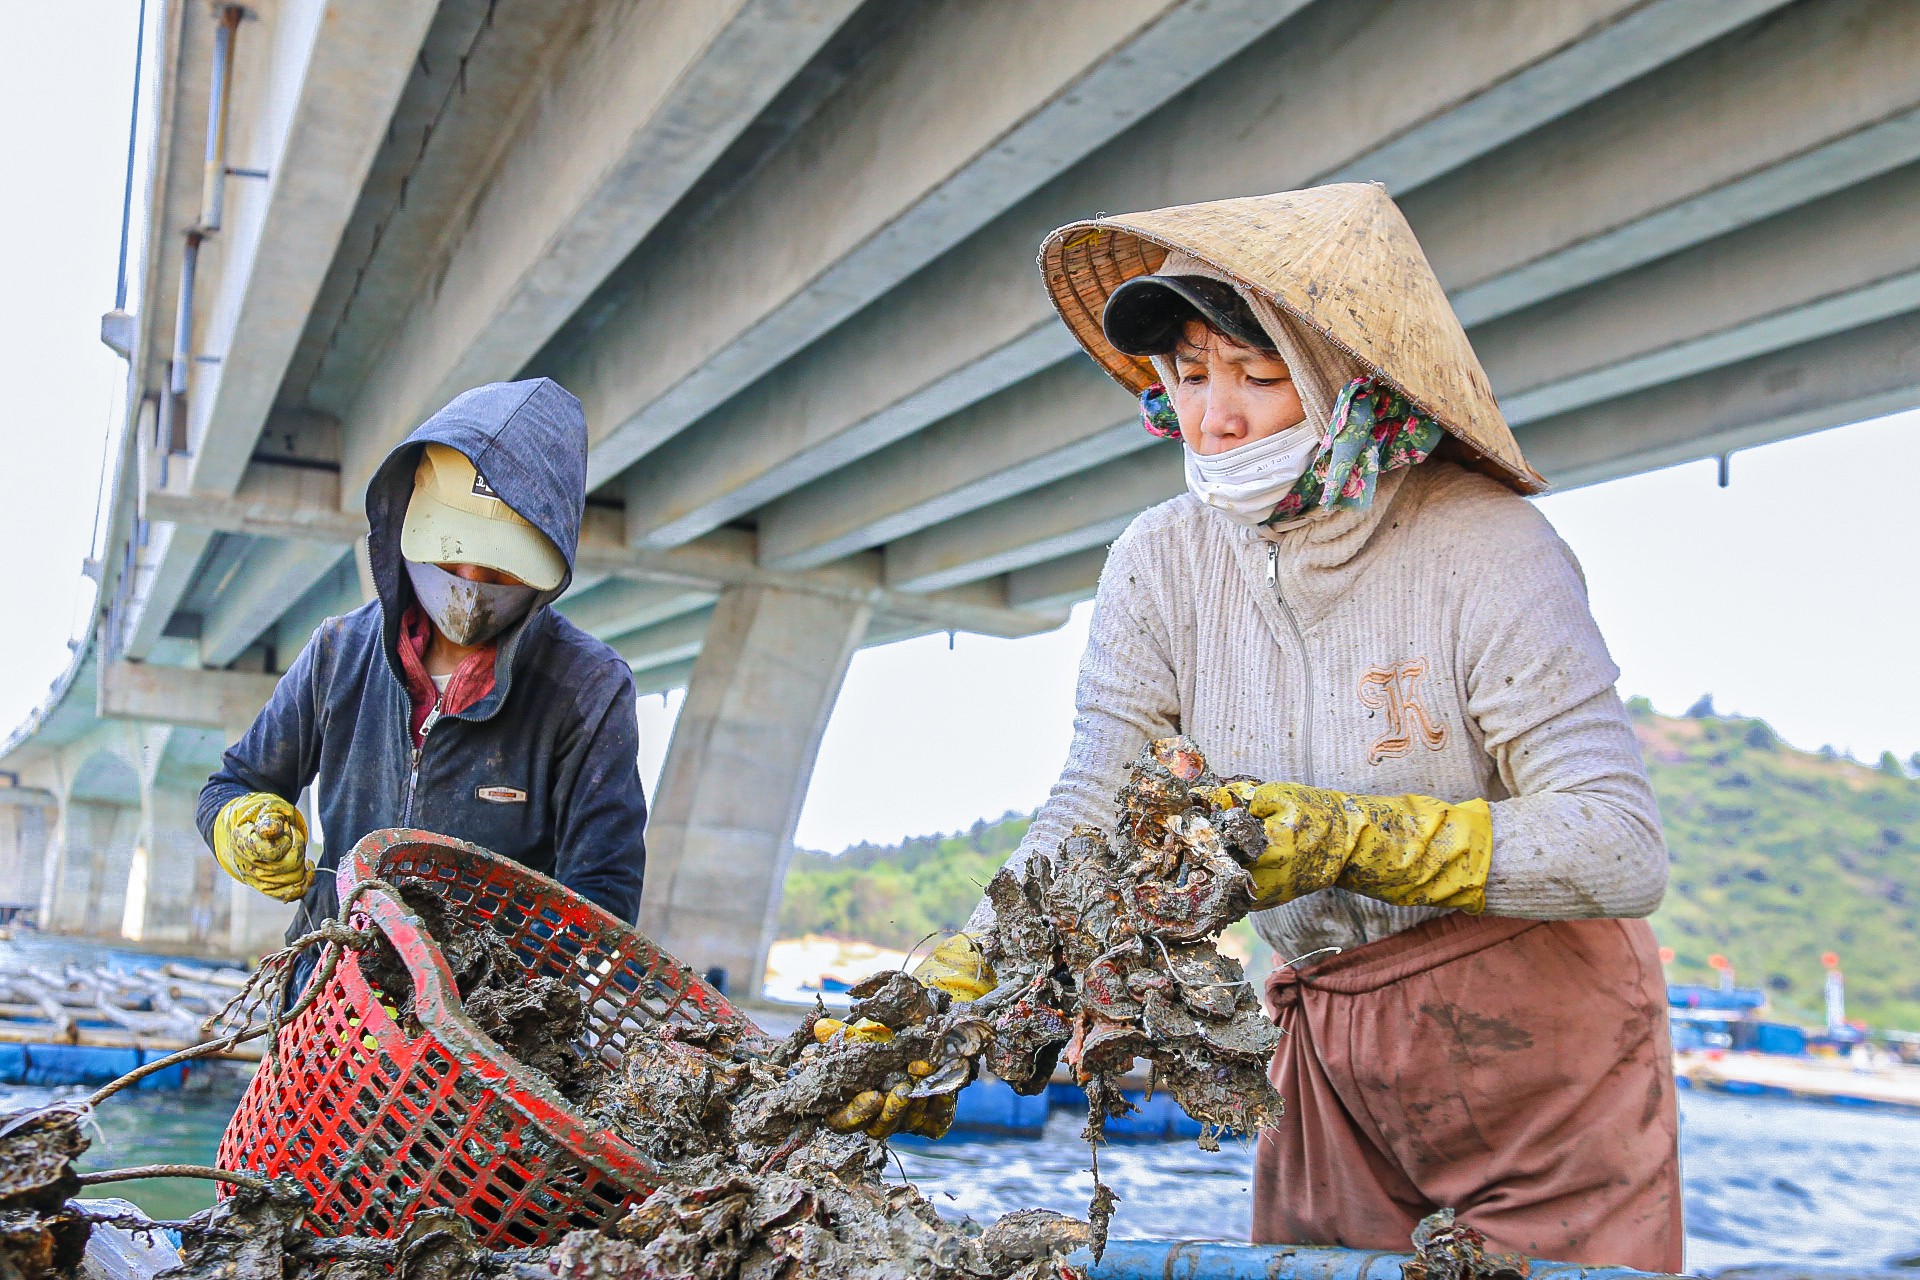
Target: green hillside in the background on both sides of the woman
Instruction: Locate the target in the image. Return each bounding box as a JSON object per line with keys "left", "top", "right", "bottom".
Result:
{"left": 780, "top": 699, "right": 1920, "bottom": 1027}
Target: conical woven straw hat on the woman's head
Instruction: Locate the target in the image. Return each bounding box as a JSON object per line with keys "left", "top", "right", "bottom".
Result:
{"left": 1041, "top": 182, "right": 1548, "bottom": 493}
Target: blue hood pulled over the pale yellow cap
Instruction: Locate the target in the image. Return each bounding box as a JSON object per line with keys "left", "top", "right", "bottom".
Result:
{"left": 367, "top": 378, "right": 588, "bottom": 720}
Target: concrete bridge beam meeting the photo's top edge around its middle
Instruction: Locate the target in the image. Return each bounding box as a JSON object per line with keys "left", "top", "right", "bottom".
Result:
{"left": 559, "top": 0, "right": 1304, "bottom": 484}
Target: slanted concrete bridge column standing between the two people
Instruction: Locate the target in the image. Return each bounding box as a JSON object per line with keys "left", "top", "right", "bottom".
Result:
{"left": 639, "top": 587, "right": 872, "bottom": 996}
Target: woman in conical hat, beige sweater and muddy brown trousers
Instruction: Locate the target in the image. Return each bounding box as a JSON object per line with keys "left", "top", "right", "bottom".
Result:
{"left": 960, "top": 184, "right": 1680, "bottom": 1272}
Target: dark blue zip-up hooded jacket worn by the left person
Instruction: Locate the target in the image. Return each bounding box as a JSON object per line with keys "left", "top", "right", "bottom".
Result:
{"left": 198, "top": 378, "right": 647, "bottom": 938}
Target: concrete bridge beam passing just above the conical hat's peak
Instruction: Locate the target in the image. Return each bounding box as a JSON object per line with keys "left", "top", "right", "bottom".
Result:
{"left": 618, "top": 0, "right": 1776, "bottom": 547}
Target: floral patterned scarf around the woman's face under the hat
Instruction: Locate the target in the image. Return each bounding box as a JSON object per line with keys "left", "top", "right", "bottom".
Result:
{"left": 1140, "top": 376, "right": 1444, "bottom": 526}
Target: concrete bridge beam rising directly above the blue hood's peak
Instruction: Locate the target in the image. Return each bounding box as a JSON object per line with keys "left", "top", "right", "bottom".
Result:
{"left": 346, "top": 0, "right": 858, "bottom": 495}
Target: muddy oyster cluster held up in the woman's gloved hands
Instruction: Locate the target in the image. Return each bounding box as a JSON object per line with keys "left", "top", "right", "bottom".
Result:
{"left": 973, "top": 737, "right": 1281, "bottom": 1150}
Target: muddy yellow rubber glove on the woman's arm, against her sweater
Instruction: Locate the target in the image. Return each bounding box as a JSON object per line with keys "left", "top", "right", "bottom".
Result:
{"left": 1213, "top": 783, "right": 1494, "bottom": 915}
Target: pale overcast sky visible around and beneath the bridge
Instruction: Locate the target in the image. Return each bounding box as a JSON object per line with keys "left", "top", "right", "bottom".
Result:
{"left": 15, "top": 0, "right": 1920, "bottom": 848}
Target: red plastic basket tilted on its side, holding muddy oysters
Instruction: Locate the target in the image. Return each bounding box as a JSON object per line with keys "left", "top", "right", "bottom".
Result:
{"left": 219, "top": 829, "right": 753, "bottom": 1247}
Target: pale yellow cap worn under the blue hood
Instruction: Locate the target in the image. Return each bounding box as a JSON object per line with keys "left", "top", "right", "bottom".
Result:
{"left": 399, "top": 443, "right": 566, "bottom": 591}
